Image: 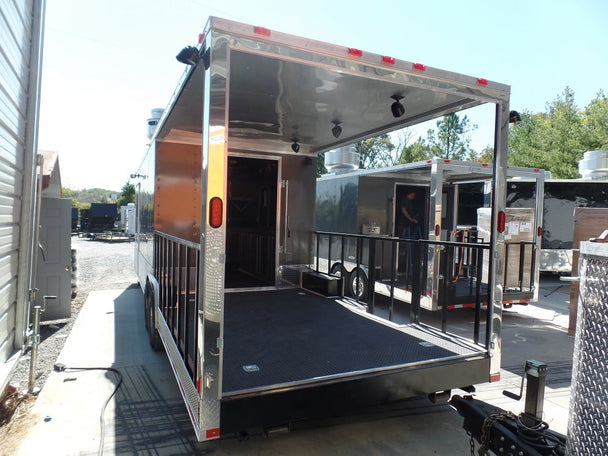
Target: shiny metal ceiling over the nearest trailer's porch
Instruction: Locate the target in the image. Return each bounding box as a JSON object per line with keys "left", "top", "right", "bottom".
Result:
{"left": 157, "top": 36, "right": 506, "bottom": 154}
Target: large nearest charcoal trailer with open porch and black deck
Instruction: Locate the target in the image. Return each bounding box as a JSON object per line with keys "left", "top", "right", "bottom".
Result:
{"left": 135, "top": 18, "right": 509, "bottom": 440}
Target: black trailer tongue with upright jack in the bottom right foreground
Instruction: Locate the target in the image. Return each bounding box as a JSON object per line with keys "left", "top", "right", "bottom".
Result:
{"left": 450, "top": 360, "right": 566, "bottom": 456}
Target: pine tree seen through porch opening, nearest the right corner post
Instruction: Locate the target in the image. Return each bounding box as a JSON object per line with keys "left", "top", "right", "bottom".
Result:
{"left": 427, "top": 113, "right": 477, "bottom": 160}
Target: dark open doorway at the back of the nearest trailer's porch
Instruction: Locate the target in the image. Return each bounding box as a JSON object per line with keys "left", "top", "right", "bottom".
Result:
{"left": 226, "top": 156, "right": 278, "bottom": 288}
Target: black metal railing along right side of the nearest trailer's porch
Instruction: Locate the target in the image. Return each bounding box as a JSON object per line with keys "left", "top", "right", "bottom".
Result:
{"left": 313, "top": 230, "right": 534, "bottom": 346}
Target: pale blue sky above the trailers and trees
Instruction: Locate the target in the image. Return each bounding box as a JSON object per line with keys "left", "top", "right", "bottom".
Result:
{"left": 38, "top": 0, "right": 608, "bottom": 190}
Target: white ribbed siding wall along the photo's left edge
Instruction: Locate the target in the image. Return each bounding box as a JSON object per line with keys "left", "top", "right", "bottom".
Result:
{"left": 0, "top": 0, "right": 45, "bottom": 392}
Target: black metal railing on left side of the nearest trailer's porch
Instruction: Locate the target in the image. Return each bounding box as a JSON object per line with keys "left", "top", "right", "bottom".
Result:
{"left": 154, "top": 232, "right": 200, "bottom": 380}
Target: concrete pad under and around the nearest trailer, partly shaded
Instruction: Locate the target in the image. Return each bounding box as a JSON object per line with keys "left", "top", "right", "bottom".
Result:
{"left": 16, "top": 278, "right": 574, "bottom": 456}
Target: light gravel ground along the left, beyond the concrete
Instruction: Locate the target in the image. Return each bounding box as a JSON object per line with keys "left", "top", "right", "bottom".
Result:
{"left": 0, "top": 237, "right": 137, "bottom": 432}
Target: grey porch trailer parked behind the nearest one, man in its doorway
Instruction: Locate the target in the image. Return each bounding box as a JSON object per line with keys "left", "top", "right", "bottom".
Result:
{"left": 315, "top": 158, "right": 544, "bottom": 310}
